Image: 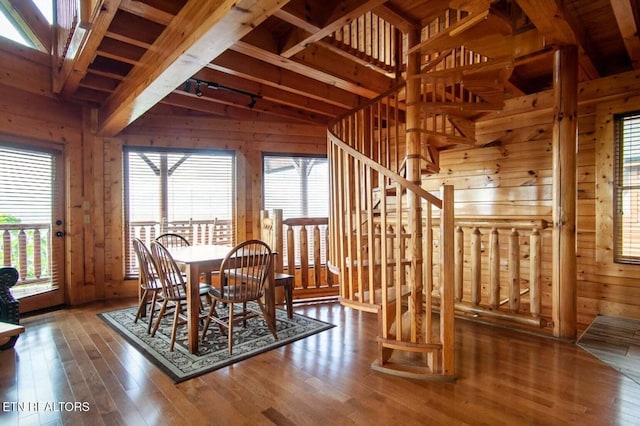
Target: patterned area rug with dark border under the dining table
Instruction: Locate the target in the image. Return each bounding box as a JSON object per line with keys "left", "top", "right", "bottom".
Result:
{"left": 98, "top": 305, "right": 334, "bottom": 383}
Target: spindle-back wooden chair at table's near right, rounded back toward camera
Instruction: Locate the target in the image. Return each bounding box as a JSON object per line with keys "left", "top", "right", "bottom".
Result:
{"left": 202, "top": 240, "right": 278, "bottom": 355}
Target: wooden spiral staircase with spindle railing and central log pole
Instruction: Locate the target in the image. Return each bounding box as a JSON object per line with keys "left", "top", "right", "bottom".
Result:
{"left": 328, "top": 5, "right": 513, "bottom": 380}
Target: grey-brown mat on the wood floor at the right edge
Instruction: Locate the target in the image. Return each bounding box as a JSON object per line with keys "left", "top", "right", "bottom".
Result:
{"left": 577, "top": 315, "right": 640, "bottom": 384}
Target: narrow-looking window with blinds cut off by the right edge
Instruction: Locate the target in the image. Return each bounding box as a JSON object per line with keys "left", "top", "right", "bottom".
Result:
{"left": 614, "top": 112, "right": 640, "bottom": 264}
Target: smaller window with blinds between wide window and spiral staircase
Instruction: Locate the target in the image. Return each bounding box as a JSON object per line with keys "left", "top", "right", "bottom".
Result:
{"left": 263, "top": 155, "right": 329, "bottom": 265}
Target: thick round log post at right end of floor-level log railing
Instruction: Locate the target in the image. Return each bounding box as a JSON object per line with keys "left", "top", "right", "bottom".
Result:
{"left": 551, "top": 46, "right": 578, "bottom": 340}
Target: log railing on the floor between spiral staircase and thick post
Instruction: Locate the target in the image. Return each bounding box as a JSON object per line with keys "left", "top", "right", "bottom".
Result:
{"left": 434, "top": 217, "right": 552, "bottom": 331}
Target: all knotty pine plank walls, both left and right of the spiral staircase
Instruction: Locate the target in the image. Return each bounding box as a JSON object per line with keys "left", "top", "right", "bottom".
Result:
{"left": 0, "top": 35, "right": 640, "bottom": 330}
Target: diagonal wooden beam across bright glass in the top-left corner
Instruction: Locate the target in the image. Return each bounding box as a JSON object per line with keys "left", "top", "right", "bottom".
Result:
{"left": 0, "top": 0, "right": 51, "bottom": 53}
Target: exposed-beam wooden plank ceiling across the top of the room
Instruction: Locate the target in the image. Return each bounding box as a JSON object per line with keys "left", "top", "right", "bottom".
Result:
{"left": 25, "top": 0, "right": 640, "bottom": 135}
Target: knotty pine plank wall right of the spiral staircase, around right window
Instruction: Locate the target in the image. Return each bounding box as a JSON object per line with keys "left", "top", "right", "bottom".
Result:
{"left": 424, "top": 72, "right": 640, "bottom": 328}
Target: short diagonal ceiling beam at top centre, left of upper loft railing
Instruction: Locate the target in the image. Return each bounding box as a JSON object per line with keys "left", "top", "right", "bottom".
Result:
{"left": 279, "top": 0, "right": 386, "bottom": 58}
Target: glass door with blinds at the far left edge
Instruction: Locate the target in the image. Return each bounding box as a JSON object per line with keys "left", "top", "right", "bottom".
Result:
{"left": 0, "top": 144, "right": 64, "bottom": 313}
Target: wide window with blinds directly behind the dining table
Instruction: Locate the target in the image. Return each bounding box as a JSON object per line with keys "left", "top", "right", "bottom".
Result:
{"left": 124, "top": 148, "right": 235, "bottom": 276}
